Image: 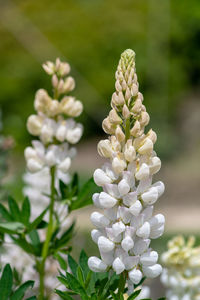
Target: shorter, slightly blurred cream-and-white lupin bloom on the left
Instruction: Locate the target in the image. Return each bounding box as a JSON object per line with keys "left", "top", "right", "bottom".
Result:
{"left": 25, "top": 59, "right": 83, "bottom": 173}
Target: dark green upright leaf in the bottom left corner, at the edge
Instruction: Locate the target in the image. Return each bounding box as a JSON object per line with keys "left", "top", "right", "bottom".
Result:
{"left": 0, "top": 264, "right": 13, "bottom": 300}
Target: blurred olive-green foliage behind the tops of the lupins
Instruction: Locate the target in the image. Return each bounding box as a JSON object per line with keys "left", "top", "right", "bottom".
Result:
{"left": 0, "top": 0, "right": 200, "bottom": 157}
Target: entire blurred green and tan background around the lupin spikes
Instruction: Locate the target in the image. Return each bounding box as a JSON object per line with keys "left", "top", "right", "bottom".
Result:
{"left": 0, "top": 0, "right": 200, "bottom": 296}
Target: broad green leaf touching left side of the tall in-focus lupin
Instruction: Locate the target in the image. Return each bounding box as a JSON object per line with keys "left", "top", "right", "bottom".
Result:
{"left": 69, "top": 178, "right": 98, "bottom": 211}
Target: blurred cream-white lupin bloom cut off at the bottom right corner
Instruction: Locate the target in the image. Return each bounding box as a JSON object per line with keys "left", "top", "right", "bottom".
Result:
{"left": 161, "top": 236, "right": 200, "bottom": 300}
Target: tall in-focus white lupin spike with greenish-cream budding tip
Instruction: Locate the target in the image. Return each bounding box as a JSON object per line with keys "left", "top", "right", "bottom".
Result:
{"left": 88, "top": 50, "right": 165, "bottom": 293}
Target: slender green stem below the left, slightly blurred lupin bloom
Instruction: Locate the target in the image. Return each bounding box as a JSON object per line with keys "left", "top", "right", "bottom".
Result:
{"left": 38, "top": 167, "right": 55, "bottom": 300}
